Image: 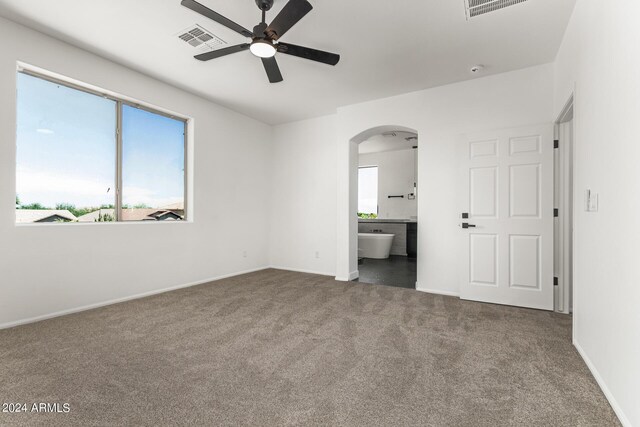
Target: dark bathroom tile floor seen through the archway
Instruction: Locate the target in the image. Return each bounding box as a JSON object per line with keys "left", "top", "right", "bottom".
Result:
{"left": 355, "top": 255, "right": 416, "bottom": 289}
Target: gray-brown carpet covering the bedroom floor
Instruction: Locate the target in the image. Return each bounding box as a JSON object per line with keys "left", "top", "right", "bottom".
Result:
{"left": 0, "top": 270, "right": 618, "bottom": 426}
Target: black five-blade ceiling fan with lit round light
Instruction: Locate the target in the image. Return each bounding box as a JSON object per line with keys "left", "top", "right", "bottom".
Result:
{"left": 182, "top": 0, "right": 340, "bottom": 83}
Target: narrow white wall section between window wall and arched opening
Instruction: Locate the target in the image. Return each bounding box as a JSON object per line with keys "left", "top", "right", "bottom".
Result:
{"left": 269, "top": 116, "right": 337, "bottom": 275}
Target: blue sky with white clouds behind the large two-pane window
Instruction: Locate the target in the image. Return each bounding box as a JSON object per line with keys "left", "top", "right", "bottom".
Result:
{"left": 16, "top": 73, "right": 184, "bottom": 211}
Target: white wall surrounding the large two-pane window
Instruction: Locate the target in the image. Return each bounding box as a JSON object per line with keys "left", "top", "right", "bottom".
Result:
{"left": 0, "top": 18, "right": 272, "bottom": 327}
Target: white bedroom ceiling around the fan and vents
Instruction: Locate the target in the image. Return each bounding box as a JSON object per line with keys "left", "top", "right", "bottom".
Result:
{"left": 0, "top": 0, "right": 575, "bottom": 124}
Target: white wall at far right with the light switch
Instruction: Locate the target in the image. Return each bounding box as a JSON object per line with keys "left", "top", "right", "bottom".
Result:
{"left": 554, "top": 0, "right": 640, "bottom": 426}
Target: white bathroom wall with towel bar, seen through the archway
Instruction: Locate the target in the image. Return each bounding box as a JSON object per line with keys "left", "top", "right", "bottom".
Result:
{"left": 358, "top": 150, "right": 418, "bottom": 219}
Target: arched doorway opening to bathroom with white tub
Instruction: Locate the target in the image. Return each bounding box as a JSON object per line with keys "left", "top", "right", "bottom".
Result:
{"left": 355, "top": 129, "right": 418, "bottom": 289}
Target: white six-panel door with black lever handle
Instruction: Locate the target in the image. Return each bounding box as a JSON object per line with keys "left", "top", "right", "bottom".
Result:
{"left": 459, "top": 125, "right": 553, "bottom": 310}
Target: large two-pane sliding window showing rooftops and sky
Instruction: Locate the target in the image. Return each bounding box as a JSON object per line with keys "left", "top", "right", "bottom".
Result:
{"left": 16, "top": 72, "right": 186, "bottom": 223}
